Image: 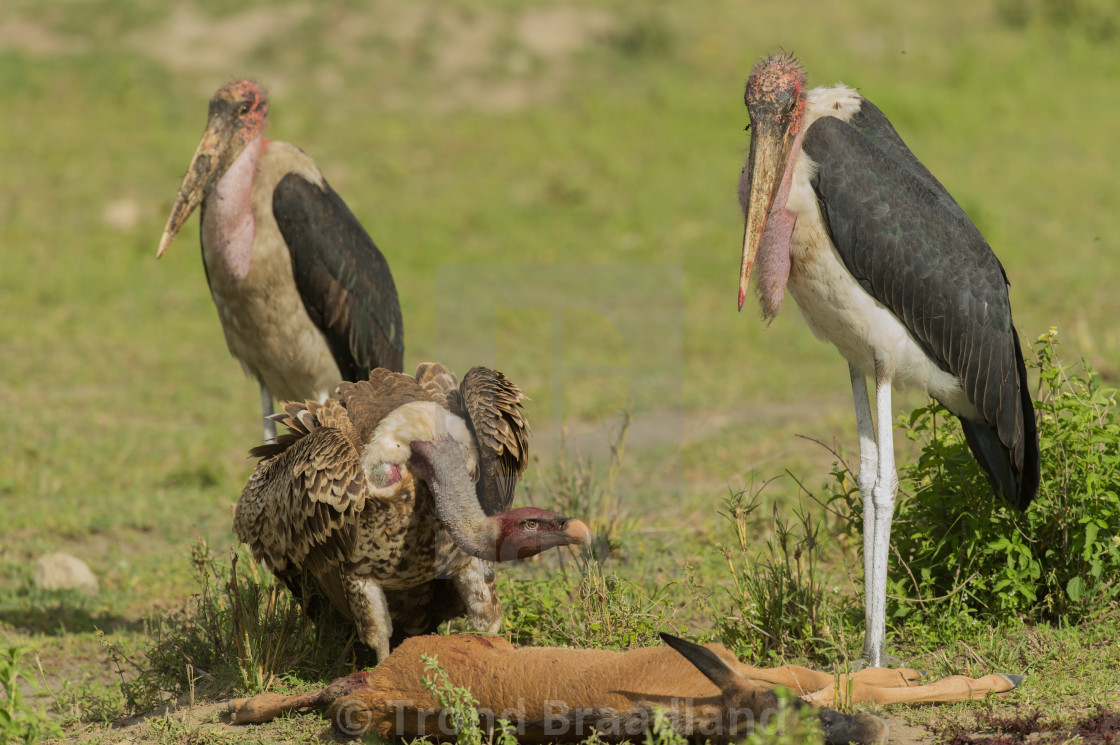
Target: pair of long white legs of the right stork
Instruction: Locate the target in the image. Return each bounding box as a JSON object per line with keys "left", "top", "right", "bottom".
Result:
{"left": 864, "top": 370, "right": 898, "bottom": 668}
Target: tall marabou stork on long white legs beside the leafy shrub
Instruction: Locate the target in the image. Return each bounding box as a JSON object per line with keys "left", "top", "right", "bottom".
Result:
{"left": 739, "top": 55, "right": 1039, "bottom": 665}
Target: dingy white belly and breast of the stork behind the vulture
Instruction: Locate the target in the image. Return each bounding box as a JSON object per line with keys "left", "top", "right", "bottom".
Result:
{"left": 202, "top": 143, "right": 342, "bottom": 401}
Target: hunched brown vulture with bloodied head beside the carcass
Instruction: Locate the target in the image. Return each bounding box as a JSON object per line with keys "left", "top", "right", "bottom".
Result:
{"left": 233, "top": 363, "right": 590, "bottom": 660}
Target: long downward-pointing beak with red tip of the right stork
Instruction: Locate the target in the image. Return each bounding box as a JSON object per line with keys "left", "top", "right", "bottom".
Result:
{"left": 739, "top": 117, "right": 794, "bottom": 310}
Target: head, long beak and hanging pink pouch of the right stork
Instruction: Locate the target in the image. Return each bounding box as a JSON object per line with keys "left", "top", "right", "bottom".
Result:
{"left": 739, "top": 54, "right": 805, "bottom": 317}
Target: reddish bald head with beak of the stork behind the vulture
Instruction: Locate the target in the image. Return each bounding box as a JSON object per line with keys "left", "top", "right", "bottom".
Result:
{"left": 156, "top": 80, "right": 269, "bottom": 257}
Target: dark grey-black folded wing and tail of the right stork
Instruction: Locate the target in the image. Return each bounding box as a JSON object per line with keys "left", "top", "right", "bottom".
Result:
{"left": 803, "top": 101, "right": 1039, "bottom": 509}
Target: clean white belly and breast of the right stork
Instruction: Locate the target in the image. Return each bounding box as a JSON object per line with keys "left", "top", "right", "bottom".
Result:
{"left": 786, "top": 165, "right": 979, "bottom": 418}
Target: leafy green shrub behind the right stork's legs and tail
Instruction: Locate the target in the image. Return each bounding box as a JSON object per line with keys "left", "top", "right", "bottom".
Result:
{"left": 834, "top": 329, "right": 1120, "bottom": 622}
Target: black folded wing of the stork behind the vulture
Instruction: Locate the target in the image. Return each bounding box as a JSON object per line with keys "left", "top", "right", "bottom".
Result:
{"left": 272, "top": 174, "right": 404, "bottom": 381}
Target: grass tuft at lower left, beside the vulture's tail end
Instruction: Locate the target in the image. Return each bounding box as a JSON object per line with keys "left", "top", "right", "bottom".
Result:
{"left": 114, "top": 541, "right": 353, "bottom": 711}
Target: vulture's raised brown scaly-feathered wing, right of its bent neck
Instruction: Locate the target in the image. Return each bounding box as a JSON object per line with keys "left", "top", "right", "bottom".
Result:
{"left": 447, "top": 367, "right": 532, "bottom": 515}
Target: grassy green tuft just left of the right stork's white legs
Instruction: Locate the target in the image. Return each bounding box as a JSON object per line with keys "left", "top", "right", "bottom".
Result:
{"left": 716, "top": 492, "right": 838, "bottom": 662}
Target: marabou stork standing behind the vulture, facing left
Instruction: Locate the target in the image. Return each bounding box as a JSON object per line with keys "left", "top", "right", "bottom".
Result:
{"left": 158, "top": 81, "right": 404, "bottom": 440}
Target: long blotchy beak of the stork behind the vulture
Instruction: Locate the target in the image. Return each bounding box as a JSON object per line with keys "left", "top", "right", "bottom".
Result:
{"left": 156, "top": 110, "right": 245, "bottom": 259}
